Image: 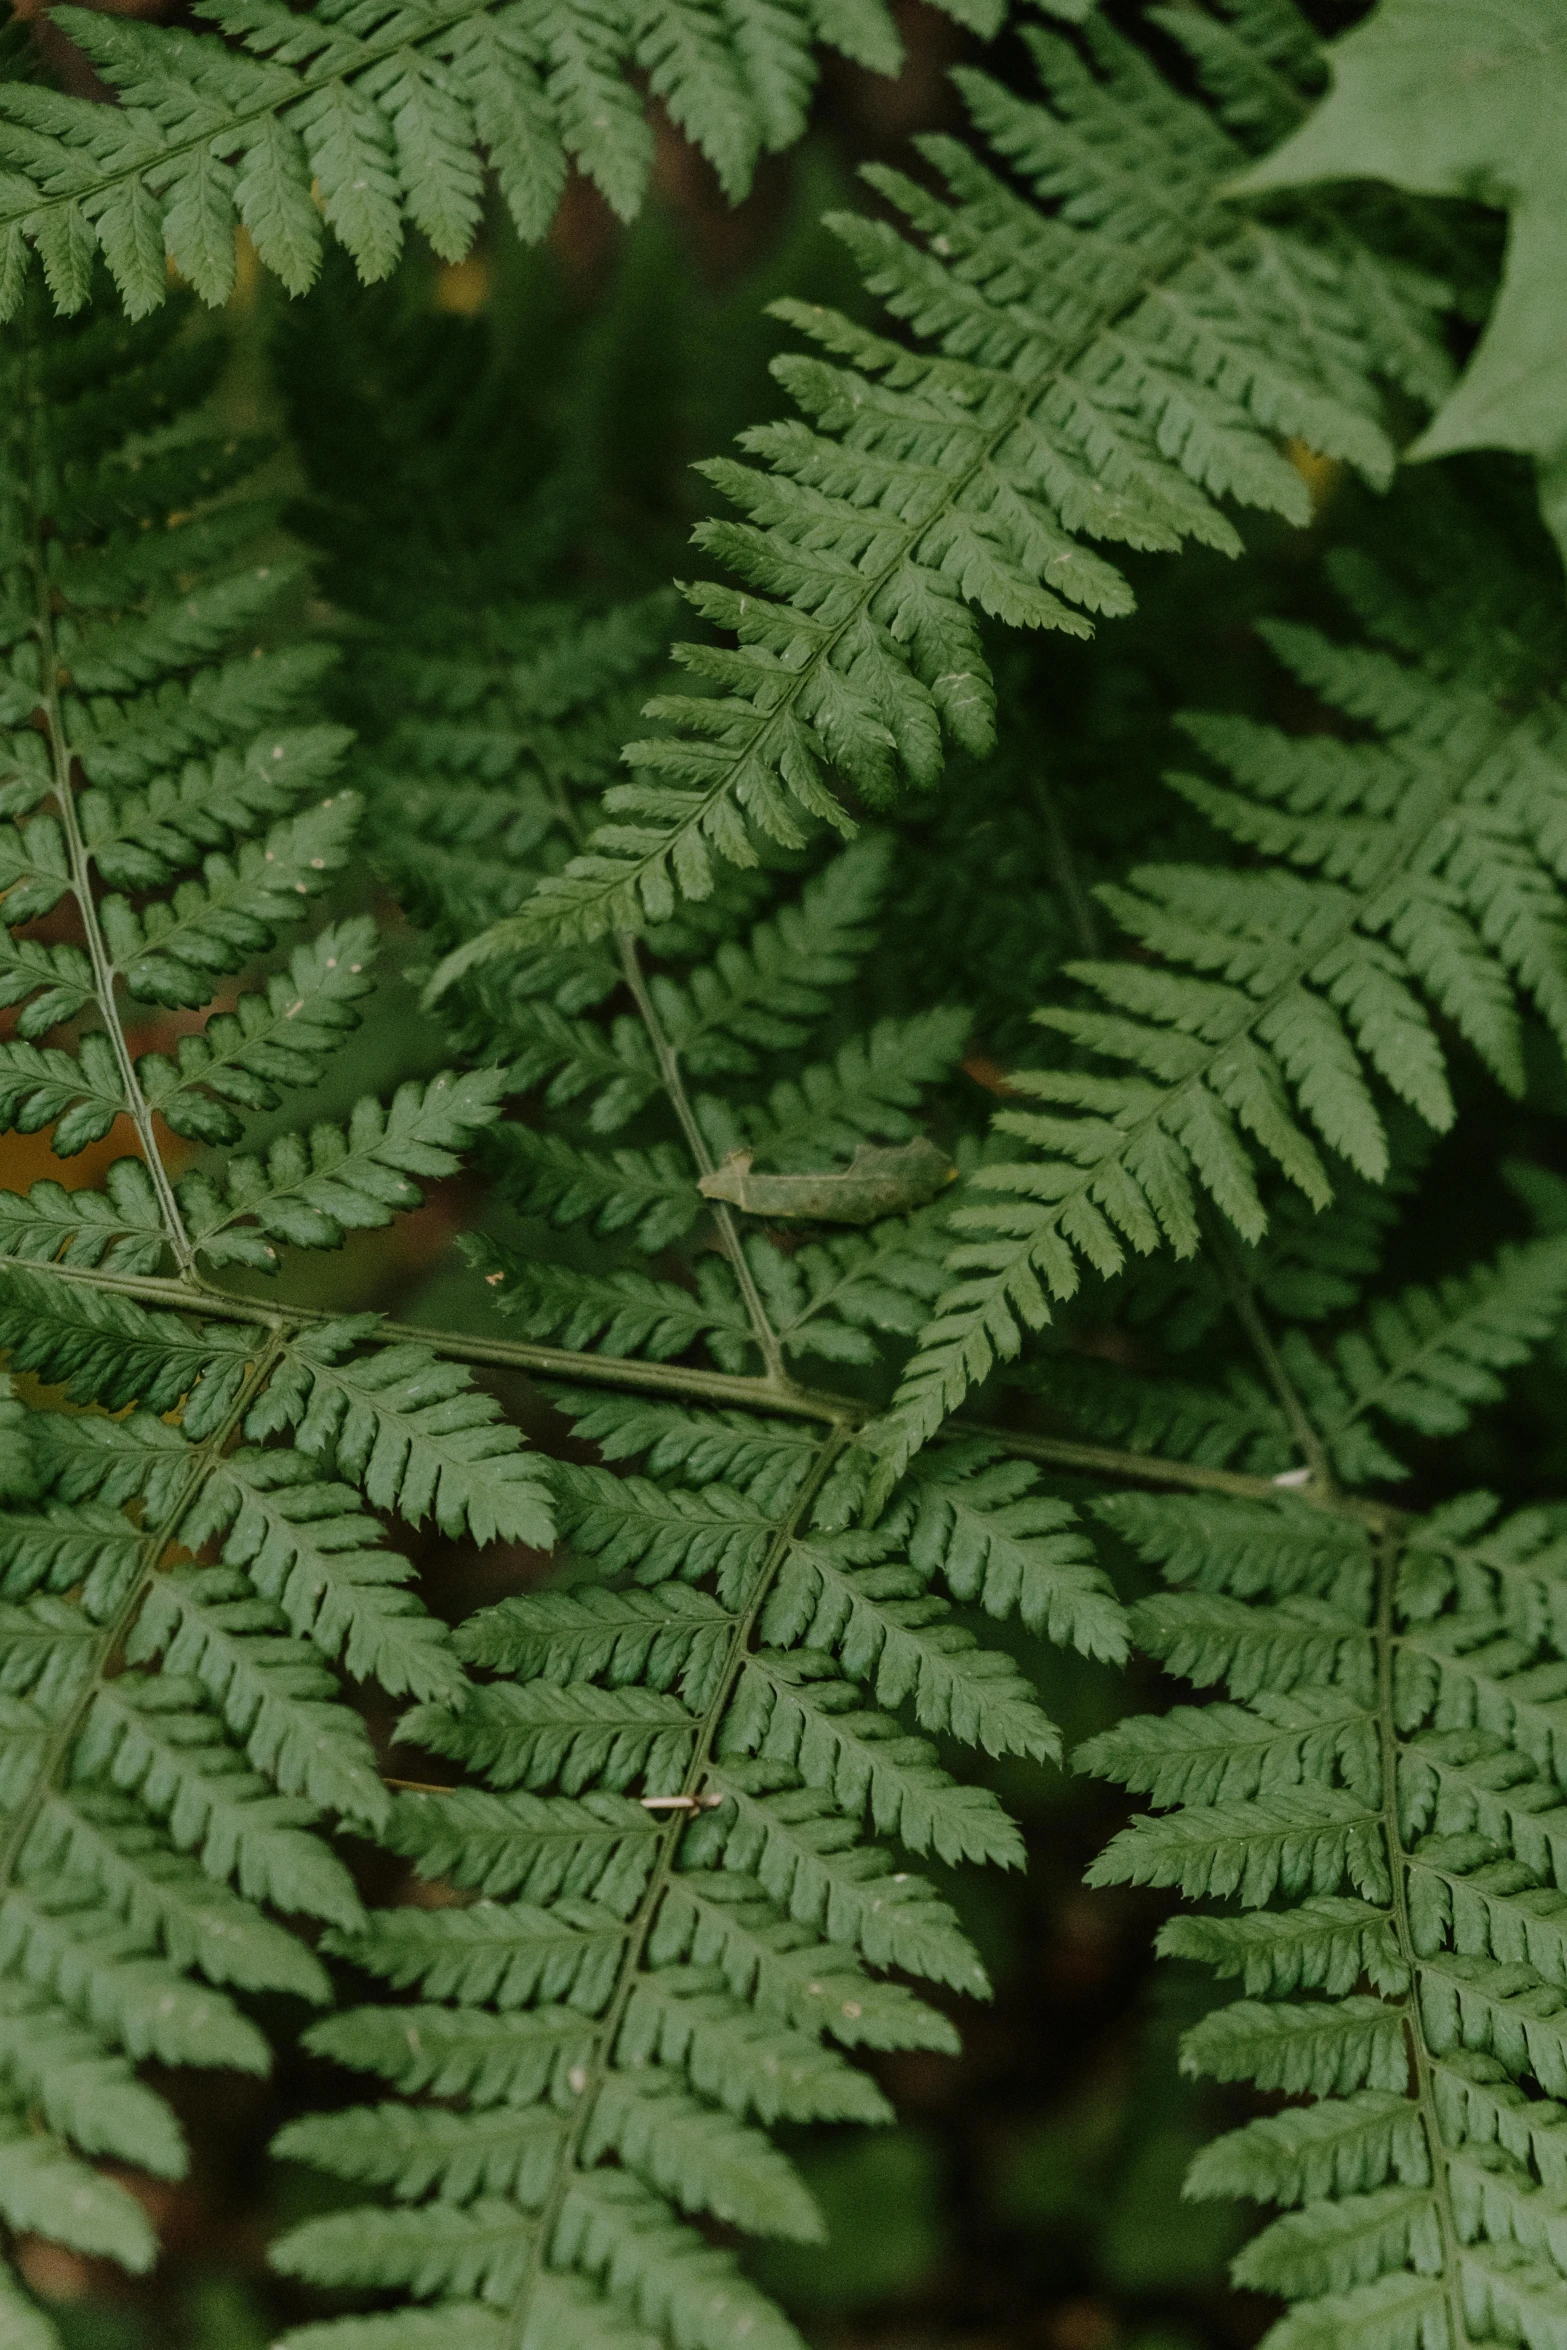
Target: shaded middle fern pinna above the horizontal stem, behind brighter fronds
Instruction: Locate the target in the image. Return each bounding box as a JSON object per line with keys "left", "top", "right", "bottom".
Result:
{"left": 285, "top": 291, "right": 975, "bottom": 1375}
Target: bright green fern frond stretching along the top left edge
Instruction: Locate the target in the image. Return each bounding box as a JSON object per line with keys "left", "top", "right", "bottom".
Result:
{"left": 0, "top": 0, "right": 1001, "bottom": 320}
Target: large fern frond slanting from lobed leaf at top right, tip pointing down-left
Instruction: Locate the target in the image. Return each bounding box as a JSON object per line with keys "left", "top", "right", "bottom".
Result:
{"left": 446, "top": 0, "right": 1442, "bottom": 973}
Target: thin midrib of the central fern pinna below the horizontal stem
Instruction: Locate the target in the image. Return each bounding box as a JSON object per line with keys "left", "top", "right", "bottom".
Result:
{"left": 503, "top": 1419, "right": 850, "bottom": 2350}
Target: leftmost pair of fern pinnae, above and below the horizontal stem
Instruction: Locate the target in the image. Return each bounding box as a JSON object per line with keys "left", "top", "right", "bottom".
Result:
{"left": 0, "top": 284, "right": 550, "bottom": 2327}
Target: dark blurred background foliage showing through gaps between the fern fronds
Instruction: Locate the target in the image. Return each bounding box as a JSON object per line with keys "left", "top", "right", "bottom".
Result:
{"left": 0, "top": 0, "right": 1567, "bottom": 2350}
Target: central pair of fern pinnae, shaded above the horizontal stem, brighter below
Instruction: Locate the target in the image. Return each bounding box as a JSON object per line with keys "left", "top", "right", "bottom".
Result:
{"left": 263, "top": 293, "right": 1141, "bottom": 2350}
